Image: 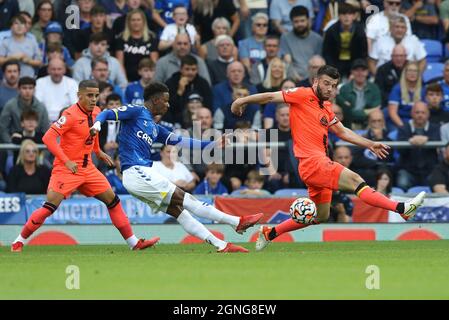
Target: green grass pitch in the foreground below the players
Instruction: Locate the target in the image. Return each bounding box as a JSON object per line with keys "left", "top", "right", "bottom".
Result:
{"left": 0, "top": 240, "right": 449, "bottom": 300}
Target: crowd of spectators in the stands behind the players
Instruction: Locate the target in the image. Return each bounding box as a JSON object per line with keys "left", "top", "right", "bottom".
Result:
{"left": 0, "top": 0, "right": 449, "bottom": 212}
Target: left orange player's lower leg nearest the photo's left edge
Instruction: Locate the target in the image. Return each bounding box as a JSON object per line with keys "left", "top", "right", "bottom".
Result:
{"left": 11, "top": 202, "right": 58, "bottom": 252}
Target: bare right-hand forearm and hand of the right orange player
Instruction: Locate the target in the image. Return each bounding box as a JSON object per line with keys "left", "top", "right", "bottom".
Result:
{"left": 329, "top": 121, "right": 390, "bottom": 159}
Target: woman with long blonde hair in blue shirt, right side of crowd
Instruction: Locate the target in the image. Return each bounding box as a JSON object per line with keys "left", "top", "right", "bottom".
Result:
{"left": 388, "top": 62, "right": 422, "bottom": 128}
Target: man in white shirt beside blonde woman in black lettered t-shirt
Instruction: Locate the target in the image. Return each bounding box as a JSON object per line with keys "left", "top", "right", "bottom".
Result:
{"left": 158, "top": 4, "right": 201, "bottom": 51}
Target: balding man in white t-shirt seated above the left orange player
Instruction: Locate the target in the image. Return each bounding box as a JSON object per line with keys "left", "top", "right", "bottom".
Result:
{"left": 36, "top": 58, "right": 78, "bottom": 122}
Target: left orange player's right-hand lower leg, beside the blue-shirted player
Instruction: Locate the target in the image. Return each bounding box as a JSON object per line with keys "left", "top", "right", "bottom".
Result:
{"left": 96, "top": 189, "right": 160, "bottom": 250}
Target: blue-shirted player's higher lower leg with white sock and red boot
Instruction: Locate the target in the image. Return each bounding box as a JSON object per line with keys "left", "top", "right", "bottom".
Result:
{"left": 183, "top": 193, "right": 263, "bottom": 234}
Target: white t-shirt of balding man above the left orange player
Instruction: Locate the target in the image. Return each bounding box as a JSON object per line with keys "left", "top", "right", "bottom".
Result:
{"left": 35, "top": 76, "right": 78, "bottom": 122}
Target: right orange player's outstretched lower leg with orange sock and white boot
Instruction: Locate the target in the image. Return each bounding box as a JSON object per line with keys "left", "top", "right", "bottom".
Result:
{"left": 338, "top": 168, "right": 426, "bottom": 220}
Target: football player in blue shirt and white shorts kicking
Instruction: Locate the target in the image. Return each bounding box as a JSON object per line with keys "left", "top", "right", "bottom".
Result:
{"left": 90, "top": 82, "right": 263, "bottom": 252}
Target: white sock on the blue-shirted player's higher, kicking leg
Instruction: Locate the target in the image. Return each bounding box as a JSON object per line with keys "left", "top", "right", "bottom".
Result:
{"left": 183, "top": 193, "right": 240, "bottom": 227}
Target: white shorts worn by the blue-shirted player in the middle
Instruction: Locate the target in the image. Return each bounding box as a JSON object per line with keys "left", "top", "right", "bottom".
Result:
{"left": 123, "top": 166, "right": 176, "bottom": 212}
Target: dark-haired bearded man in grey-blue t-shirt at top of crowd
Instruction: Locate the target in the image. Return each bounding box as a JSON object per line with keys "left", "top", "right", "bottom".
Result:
{"left": 280, "top": 5, "right": 323, "bottom": 81}
